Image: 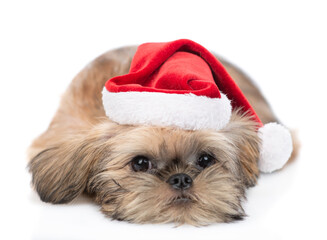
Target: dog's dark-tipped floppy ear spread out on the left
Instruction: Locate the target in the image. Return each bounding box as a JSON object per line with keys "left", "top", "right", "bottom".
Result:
{"left": 28, "top": 124, "right": 117, "bottom": 203}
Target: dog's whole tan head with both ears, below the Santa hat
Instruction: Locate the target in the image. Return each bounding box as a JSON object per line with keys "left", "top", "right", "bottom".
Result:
{"left": 30, "top": 110, "right": 259, "bottom": 225}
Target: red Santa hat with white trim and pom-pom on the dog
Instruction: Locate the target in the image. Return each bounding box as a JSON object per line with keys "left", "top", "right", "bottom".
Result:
{"left": 102, "top": 39, "right": 292, "bottom": 172}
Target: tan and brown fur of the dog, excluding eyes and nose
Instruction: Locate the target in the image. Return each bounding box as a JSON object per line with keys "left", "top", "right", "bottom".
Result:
{"left": 29, "top": 47, "right": 296, "bottom": 225}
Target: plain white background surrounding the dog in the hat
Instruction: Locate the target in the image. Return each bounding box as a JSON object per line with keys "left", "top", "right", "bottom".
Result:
{"left": 0, "top": 0, "right": 327, "bottom": 240}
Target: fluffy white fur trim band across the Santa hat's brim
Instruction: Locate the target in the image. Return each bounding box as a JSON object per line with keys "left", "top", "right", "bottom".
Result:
{"left": 102, "top": 88, "right": 232, "bottom": 130}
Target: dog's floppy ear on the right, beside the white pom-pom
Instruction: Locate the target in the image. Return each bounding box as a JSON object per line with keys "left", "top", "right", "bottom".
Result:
{"left": 224, "top": 111, "right": 260, "bottom": 187}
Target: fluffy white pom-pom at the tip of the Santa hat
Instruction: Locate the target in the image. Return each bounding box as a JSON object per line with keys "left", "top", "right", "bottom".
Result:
{"left": 258, "top": 123, "right": 293, "bottom": 173}
